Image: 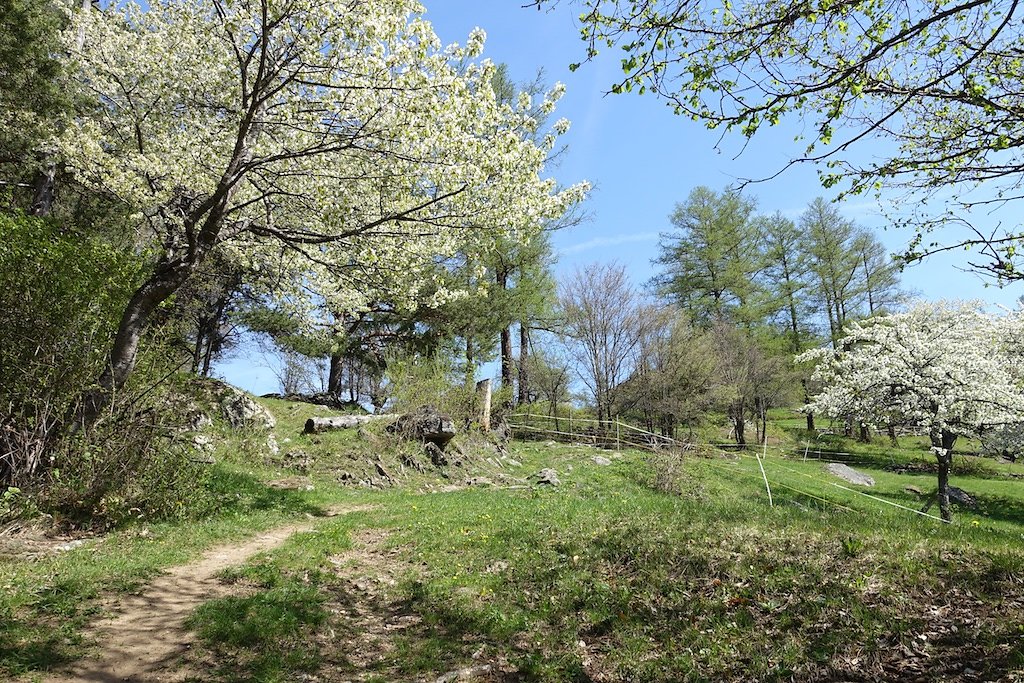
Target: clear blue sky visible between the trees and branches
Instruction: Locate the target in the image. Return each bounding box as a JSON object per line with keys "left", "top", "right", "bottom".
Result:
{"left": 219, "top": 0, "right": 1024, "bottom": 393}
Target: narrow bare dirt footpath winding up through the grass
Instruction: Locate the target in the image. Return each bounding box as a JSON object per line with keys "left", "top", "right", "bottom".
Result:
{"left": 43, "top": 507, "right": 365, "bottom": 683}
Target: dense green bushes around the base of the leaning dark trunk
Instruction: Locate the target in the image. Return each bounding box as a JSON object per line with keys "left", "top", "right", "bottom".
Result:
{"left": 0, "top": 215, "right": 223, "bottom": 525}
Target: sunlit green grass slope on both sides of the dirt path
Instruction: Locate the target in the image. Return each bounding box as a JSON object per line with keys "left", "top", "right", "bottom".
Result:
{"left": 0, "top": 401, "right": 1024, "bottom": 682}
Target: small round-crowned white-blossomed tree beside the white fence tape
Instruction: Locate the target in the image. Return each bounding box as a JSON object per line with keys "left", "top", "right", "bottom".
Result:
{"left": 798, "top": 303, "right": 1024, "bottom": 521}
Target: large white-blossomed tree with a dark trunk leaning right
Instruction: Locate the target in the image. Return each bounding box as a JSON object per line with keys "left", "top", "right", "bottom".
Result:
{"left": 58, "top": 0, "right": 586, "bottom": 422}
